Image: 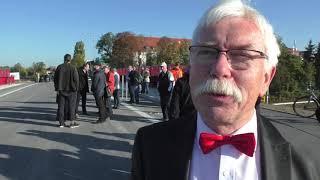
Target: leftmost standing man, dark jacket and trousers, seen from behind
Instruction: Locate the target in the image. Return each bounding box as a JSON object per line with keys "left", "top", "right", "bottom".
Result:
{"left": 54, "top": 54, "right": 79, "bottom": 128}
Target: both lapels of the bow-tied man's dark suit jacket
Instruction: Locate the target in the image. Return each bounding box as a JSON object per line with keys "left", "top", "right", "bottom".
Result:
{"left": 171, "top": 111, "right": 292, "bottom": 180}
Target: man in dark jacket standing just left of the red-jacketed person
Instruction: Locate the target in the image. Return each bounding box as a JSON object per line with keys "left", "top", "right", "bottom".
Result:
{"left": 91, "top": 62, "right": 107, "bottom": 124}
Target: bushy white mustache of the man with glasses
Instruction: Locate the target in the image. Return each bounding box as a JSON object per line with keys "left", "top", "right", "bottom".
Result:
{"left": 194, "top": 79, "right": 242, "bottom": 103}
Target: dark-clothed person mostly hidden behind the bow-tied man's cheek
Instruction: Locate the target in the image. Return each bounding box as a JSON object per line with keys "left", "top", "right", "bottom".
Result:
{"left": 169, "top": 69, "right": 195, "bottom": 120}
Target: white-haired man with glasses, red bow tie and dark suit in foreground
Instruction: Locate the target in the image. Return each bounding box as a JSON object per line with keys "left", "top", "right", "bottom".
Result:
{"left": 131, "top": 0, "right": 320, "bottom": 180}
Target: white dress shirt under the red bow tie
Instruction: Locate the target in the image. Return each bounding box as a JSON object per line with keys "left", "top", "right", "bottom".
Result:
{"left": 189, "top": 111, "right": 261, "bottom": 180}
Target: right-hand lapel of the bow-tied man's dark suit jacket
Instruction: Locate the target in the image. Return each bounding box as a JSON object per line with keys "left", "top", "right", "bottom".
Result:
{"left": 257, "top": 114, "right": 292, "bottom": 180}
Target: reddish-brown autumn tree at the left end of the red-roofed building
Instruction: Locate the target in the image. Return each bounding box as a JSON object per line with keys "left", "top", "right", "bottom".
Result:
{"left": 110, "top": 32, "right": 140, "bottom": 67}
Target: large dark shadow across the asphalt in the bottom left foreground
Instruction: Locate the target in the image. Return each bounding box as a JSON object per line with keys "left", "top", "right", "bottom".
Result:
{"left": 0, "top": 130, "right": 134, "bottom": 180}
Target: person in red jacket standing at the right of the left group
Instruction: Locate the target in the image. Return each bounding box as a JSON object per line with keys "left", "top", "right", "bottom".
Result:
{"left": 104, "top": 65, "right": 114, "bottom": 117}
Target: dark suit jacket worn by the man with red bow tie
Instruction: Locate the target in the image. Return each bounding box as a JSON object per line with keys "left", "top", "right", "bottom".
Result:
{"left": 131, "top": 111, "right": 320, "bottom": 180}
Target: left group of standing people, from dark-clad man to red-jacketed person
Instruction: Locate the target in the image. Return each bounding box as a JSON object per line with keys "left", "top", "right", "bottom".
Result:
{"left": 54, "top": 54, "right": 120, "bottom": 128}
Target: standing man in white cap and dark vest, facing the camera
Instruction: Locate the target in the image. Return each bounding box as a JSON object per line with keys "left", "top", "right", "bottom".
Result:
{"left": 157, "top": 62, "right": 174, "bottom": 121}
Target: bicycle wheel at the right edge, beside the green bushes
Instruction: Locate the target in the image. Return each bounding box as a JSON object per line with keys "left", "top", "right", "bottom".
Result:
{"left": 293, "top": 96, "right": 318, "bottom": 117}
